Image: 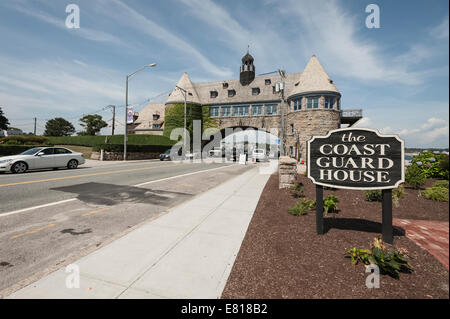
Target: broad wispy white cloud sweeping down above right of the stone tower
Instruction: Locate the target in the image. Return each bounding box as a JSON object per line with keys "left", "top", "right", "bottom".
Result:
{"left": 274, "top": 0, "right": 435, "bottom": 85}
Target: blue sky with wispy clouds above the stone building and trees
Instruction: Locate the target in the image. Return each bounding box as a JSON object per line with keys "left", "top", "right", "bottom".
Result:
{"left": 0, "top": 0, "right": 449, "bottom": 147}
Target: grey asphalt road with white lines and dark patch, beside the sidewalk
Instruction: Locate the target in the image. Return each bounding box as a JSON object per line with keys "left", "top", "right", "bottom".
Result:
{"left": 0, "top": 161, "right": 248, "bottom": 296}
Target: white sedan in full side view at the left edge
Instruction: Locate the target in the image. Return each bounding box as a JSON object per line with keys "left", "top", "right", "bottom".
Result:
{"left": 0, "top": 147, "right": 85, "bottom": 174}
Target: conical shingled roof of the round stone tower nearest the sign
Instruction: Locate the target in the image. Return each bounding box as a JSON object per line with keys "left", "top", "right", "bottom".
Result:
{"left": 290, "top": 55, "right": 340, "bottom": 95}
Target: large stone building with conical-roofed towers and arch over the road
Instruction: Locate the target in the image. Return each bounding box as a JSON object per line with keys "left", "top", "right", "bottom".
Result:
{"left": 130, "top": 52, "right": 362, "bottom": 158}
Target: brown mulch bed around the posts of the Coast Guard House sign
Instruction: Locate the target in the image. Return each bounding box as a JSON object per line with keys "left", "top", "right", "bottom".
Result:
{"left": 222, "top": 175, "right": 449, "bottom": 298}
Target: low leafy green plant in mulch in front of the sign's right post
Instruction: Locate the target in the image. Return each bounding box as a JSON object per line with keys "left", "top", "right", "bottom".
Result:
{"left": 347, "top": 237, "right": 412, "bottom": 279}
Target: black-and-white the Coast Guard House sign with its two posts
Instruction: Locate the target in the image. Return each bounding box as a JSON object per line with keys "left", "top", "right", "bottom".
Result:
{"left": 307, "top": 128, "right": 405, "bottom": 243}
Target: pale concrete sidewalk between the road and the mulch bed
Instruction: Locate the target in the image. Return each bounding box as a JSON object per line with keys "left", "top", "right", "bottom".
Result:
{"left": 8, "top": 168, "right": 270, "bottom": 298}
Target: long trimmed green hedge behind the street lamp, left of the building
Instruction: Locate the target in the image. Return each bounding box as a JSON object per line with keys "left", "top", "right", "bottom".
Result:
{"left": 49, "top": 134, "right": 175, "bottom": 147}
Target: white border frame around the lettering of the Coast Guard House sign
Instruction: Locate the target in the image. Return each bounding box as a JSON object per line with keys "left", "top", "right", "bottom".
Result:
{"left": 307, "top": 127, "right": 405, "bottom": 190}
